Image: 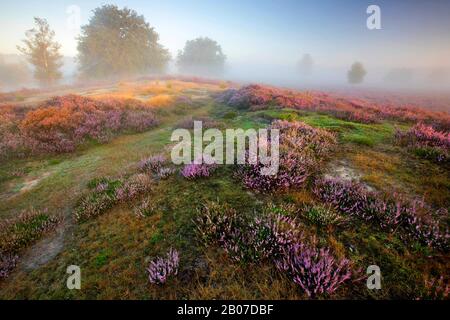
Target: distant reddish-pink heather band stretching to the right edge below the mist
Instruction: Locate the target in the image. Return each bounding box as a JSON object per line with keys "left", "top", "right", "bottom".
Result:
{"left": 217, "top": 85, "right": 450, "bottom": 129}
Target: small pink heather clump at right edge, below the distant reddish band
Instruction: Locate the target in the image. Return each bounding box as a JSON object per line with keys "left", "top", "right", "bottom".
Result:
{"left": 395, "top": 124, "right": 450, "bottom": 162}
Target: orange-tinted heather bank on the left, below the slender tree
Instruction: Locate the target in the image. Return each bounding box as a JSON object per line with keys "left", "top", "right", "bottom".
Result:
{"left": 0, "top": 95, "right": 158, "bottom": 158}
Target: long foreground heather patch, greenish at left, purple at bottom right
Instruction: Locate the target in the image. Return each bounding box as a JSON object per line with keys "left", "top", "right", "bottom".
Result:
{"left": 196, "top": 203, "right": 352, "bottom": 298}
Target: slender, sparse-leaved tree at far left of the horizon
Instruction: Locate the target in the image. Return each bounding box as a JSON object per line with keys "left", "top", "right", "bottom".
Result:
{"left": 17, "top": 18, "right": 63, "bottom": 86}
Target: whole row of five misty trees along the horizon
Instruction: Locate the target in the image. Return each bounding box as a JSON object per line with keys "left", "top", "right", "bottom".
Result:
{"left": 17, "top": 5, "right": 426, "bottom": 86}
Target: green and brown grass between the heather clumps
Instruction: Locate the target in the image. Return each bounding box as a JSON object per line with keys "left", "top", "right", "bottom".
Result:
{"left": 0, "top": 81, "right": 450, "bottom": 299}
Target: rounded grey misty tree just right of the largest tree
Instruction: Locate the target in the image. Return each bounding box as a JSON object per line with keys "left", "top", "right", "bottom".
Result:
{"left": 177, "top": 38, "right": 226, "bottom": 74}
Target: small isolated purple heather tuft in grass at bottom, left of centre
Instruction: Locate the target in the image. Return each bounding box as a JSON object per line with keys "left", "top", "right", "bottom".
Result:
{"left": 147, "top": 249, "right": 180, "bottom": 284}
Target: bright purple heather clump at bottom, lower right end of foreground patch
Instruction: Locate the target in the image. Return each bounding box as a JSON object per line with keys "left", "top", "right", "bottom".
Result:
{"left": 276, "top": 242, "right": 352, "bottom": 297}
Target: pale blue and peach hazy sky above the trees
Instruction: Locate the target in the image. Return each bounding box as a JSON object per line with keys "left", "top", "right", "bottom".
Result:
{"left": 0, "top": 0, "right": 450, "bottom": 87}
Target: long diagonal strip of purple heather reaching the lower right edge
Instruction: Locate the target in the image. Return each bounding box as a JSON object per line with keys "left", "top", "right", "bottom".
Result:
{"left": 314, "top": 179, "right": 450, "bottom": 250}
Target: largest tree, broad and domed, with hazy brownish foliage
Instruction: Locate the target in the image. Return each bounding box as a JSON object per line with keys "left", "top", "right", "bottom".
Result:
{"left": 78, "top": 5, "right": 170, "bottom": 78}
